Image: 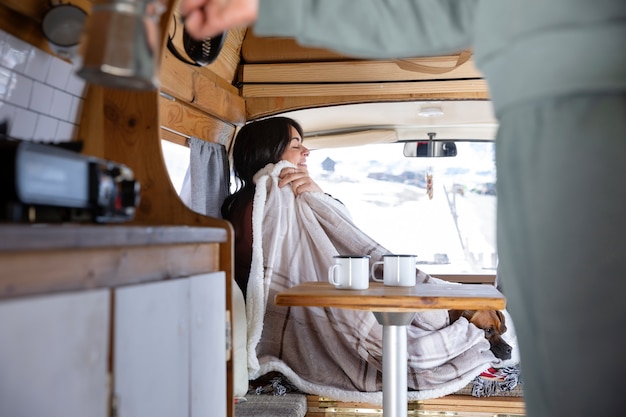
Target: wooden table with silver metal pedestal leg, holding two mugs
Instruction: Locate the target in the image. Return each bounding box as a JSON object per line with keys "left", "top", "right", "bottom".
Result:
{"left": 274, "top": 282, "right": 506, "bottom": 417}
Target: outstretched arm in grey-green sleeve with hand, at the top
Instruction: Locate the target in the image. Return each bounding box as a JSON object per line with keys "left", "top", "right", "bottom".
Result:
{"left": 181, "top": 0, "right": 478, "bottom": 58}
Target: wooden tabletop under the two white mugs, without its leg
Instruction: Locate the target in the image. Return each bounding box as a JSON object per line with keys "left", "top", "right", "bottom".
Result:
{"left": 274, "top": 282, "right": 506, "bottom": 312}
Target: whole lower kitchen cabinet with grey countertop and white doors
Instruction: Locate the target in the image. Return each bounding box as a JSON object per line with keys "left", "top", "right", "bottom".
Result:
{"left": 0, "top": 225, "right": 233, "bottom": 417}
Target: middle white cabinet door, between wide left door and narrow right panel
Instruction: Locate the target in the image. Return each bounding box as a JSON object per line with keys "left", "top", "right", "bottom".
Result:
{"left": 113, "top": 279, "right": 189, "bottom": 417}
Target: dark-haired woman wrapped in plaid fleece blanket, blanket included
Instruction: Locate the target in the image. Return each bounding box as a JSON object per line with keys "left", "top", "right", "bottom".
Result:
{"left": 222, "top": 117, "right": 499, "bottom": 403}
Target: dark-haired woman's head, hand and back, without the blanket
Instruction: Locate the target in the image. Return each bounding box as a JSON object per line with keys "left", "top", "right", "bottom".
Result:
{"left": 222, "top": 117, "right": 322, "bottom": 298}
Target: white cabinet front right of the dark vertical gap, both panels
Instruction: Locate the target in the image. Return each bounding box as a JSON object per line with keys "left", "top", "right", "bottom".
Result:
{"left": 113, "top": 272, "right": 226, "bottom": 417}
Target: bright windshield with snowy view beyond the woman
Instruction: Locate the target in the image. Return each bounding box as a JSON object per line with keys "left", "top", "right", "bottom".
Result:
{"left": 305, "top": 142, "right": 497, "bottom": 274}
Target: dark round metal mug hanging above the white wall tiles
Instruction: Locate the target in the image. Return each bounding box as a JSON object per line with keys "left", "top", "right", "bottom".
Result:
{"left": 41, "top": 4, "right": 87, "bottom": 61}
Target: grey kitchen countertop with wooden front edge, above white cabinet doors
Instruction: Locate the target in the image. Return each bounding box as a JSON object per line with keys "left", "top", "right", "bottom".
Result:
{"left": 0, "top": 224, "right": 228, "bottom": 300}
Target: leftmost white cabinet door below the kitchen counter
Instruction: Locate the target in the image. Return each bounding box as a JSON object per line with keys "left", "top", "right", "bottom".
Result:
{"left": 0, "top": 290, "right": 110, "bottom": 417}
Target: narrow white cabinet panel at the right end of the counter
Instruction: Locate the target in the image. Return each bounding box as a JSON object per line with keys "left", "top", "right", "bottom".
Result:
{"left": 190, "top": 272, "right": 227, "bottom": 417}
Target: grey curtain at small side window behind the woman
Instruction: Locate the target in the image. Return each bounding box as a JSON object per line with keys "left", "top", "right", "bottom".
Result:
{"left": 180, "top": 137, "right": 230, "bottom": 218}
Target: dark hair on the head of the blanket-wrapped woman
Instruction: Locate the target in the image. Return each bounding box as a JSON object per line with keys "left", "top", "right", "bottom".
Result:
{"left": 233, "top": 117, "right": 303, "bottom": 187}
